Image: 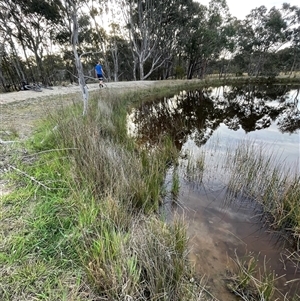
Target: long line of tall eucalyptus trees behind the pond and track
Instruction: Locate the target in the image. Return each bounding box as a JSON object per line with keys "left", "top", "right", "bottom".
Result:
{"left": 0, "top": 0, "right": 300, "bottom": 91}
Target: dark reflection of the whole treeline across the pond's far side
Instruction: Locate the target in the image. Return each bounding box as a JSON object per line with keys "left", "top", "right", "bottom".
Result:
{"left": 134, "top": 85, "right": 300, "bottom": 148}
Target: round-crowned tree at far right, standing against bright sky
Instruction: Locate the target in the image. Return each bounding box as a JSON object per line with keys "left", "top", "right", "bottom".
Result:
{"left": 239, "top": 3, "right": 300, "bottom": 76}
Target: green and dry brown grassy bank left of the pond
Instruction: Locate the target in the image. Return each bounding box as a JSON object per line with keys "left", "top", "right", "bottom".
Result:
{"left": 0, "top": 81, "right": 213, "bottom": 300}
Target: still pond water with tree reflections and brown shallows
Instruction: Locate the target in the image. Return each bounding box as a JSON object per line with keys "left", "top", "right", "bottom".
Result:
{"left": 128, "top": 86, "right": 300, "bottom": 300}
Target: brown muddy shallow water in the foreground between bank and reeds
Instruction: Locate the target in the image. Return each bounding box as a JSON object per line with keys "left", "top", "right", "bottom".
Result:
{"left": 164, "top": 155, "right": 300, "bottom": 300}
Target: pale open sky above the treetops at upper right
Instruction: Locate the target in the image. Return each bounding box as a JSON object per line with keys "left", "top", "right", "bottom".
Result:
{"left": 197, "top": 0, "right": 300, "bottom": 19}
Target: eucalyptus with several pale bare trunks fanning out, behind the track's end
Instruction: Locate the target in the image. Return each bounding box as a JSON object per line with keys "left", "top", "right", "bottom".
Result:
{"left": 123, "top": 0, "right": 190, "bottom": 80}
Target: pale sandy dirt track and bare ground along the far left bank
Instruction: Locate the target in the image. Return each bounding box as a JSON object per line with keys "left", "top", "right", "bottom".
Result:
{"left": 0, "top": 81, "right": 164, "bottom": 139}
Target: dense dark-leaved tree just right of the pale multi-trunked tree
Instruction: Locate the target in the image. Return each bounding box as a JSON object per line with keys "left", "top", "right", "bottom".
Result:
{"left": 179, "top": 0, "right": 234, "bottom": 79}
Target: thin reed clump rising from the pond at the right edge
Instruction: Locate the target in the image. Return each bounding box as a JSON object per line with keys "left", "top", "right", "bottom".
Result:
{"left": 228, "top": 141, "right": 300, "bottom": 246}
